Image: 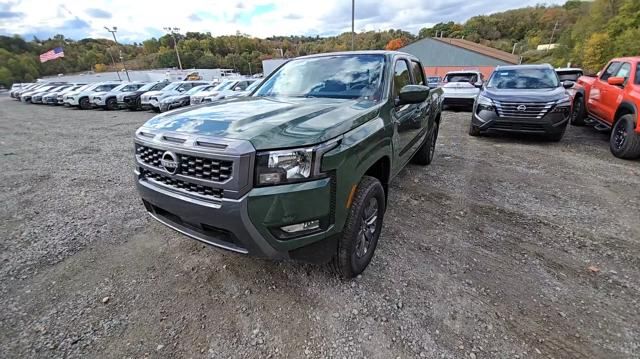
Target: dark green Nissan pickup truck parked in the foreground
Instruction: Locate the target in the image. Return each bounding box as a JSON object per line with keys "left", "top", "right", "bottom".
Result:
{"left": 135, "top": 51, "right": 442, "bottom": 278}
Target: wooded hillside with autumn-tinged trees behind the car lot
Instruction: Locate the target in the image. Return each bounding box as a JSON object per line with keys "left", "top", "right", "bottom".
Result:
{"left": 0, "top": 0, "right": 640, "bottom": 86}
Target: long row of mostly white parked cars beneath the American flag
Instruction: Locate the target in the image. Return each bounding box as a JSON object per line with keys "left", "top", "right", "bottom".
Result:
{"left": 10, "top": 78, "right": 258, "bottom": 112}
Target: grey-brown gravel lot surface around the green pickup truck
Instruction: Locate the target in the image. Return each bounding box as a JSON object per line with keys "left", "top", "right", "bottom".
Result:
{"left": 0, "top": 94, "right": 640, "bottom": 358}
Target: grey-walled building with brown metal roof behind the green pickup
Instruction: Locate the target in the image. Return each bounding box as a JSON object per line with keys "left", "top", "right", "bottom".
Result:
{"left": 398, "top": 37, "right": 520, "bottom": 76}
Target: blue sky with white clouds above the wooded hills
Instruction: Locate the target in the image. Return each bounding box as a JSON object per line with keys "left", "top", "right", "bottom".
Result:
{"left": 0, "top": 0, "right": 565, "bottom": 43}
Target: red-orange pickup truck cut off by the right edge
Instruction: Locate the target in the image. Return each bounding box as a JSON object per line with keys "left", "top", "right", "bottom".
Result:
{"left": 571, "top": 57, "right": 640, "bottom": 159}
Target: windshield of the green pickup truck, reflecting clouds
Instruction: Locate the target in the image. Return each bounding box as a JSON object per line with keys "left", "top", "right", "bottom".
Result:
{"left": 253, "top": 54, "right": 385, "bottom": 100}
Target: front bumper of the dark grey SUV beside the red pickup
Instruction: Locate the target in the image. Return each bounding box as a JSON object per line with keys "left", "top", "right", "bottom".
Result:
{"left": 471, "top": 110, "right": 571, "bottom": 135}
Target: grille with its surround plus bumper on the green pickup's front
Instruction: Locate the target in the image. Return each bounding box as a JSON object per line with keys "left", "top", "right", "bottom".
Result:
{"left": 135, "top": 134, "right": 340, "bottom": 263}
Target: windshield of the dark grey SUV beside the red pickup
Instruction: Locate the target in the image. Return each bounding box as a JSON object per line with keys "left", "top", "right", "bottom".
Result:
{"left": 487, "top": 68, "right": 560, "bottom": 89}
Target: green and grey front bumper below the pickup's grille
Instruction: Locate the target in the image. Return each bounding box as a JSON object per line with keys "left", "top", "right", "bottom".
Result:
{"left": 136, "top": 172, "right": 337, "bottom": 263}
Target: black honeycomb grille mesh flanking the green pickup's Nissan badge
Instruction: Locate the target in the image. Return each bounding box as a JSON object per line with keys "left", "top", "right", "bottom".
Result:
{"left": 136, "top": 145, "right": 233, "bottom": 182}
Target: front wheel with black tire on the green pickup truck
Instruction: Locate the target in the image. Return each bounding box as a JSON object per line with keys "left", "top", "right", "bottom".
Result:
{"left": 330, "top": 176, "right": 385, "bottom": 278}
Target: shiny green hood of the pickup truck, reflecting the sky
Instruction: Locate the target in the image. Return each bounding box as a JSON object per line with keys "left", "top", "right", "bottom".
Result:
{"left": 142, "top": 97, "right": 381, "bottom": 150}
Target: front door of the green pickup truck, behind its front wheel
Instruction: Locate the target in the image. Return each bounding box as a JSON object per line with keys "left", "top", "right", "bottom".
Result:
{"left": 391, "top": 59, "right": 423, "bottom": 167}
